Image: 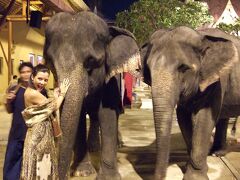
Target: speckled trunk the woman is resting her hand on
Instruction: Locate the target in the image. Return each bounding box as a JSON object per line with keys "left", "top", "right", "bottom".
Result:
{"left": 58, "top": 67, "right": 88, "bottom": 179}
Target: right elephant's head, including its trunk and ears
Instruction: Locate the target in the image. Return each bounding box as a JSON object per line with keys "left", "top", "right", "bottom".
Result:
{"left": 141, "top": 26, "right": 238, "bottom": 179}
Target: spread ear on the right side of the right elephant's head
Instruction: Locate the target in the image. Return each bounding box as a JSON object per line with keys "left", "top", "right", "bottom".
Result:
{"left": 199, "top": 36, "right": 239, "bottom": 91}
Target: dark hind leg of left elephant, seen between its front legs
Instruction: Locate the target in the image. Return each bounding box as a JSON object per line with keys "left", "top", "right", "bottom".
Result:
{"left": 88, "top": 112, "right": 100, "bottom": 152}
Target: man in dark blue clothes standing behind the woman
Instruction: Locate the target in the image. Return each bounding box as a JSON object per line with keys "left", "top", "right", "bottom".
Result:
{"left": 3, "top": 62, "right": 33, "bottom": 180}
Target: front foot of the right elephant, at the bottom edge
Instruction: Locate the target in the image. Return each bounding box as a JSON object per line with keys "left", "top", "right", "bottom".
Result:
{"left": 183, "top": 166, "right": 209, "bottom": 180}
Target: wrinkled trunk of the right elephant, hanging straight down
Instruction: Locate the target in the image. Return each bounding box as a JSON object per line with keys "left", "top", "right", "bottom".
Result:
{"left": 152, "top": 71, "right": 176, "bottom": 180}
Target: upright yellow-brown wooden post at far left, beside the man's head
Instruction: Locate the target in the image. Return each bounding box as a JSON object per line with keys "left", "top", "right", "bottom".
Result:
{"left": 8, "top": 21, "right": 13, "bottom": 83}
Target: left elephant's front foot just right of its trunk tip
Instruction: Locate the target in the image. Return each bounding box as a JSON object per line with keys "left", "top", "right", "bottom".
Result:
{"left": 72, "top": 162, "right": 96, "bottom": 177}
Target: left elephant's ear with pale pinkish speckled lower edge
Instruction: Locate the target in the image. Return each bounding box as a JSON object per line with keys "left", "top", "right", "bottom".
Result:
{"left": 105, "top": 27, "right": 141, "bottom": 82}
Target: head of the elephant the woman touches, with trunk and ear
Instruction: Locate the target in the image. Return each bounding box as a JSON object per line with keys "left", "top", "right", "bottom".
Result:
{"left": 44, "top": 12, "right": 140, "bottom": 177}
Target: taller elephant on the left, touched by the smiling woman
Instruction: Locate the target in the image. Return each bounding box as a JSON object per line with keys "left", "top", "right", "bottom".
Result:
{"left": 43, "top": 11, "right": 140, "bottom": 180}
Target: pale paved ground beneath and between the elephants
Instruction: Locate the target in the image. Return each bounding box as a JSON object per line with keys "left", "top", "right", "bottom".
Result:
{"left": 0, "top": 106, "right": 240, "bottom": 180}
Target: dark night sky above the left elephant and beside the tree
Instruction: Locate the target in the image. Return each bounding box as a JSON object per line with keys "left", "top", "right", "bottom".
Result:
{"left": 84, "top": 0, "right": 137, "bottom": 20}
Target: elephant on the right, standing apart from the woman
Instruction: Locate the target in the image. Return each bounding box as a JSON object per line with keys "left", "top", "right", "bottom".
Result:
{"left": 140, "top": 26, "right": 240, "bottom": 180}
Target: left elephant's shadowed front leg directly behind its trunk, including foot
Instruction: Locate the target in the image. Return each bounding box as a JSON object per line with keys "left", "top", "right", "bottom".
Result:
{"left": 71, "top": 110, "right": 96, "bottom": 177}
